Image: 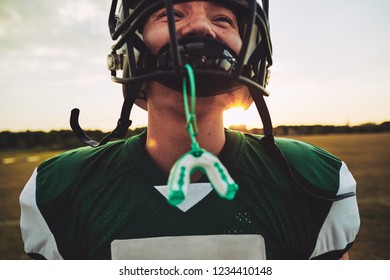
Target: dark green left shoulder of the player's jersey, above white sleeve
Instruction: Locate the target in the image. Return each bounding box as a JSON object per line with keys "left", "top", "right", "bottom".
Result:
{"left": 36, "top": 136, "right": 134, "bottom": 200}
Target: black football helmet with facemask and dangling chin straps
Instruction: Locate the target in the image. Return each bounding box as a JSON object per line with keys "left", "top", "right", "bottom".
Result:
{"left": 71, "top": 0, "right": 272, "bottom": 147}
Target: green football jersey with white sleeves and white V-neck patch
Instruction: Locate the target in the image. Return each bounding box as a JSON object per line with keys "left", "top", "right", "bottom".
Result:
{"left": 20, "top": 130, "right": 360, "bottom": 259}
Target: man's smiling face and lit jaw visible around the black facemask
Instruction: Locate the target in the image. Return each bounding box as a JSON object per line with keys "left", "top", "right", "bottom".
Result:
{"left": 143, "top": 1, "right": 252, "bottom": 109}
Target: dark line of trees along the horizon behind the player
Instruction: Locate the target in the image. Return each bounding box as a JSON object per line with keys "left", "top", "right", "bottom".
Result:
{"left": 0, "top": 122, "right": 390, "bottom": 151}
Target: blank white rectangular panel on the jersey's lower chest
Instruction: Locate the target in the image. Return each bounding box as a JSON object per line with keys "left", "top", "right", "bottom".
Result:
{"left": 111, "top": 234, "right": 266, "bottom": 260}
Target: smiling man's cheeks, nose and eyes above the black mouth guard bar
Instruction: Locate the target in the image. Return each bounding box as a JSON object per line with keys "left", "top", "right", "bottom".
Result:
{"left": 143, "top": 1, "right": 242, "bottom": 54}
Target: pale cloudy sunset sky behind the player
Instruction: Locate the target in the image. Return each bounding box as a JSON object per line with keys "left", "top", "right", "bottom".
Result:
{"left": 0, "top": 0, "right": 390, "bottom": 131}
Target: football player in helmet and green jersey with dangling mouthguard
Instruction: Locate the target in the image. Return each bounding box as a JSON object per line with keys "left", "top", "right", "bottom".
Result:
{"left": 20, "top": 0, "right": 360, "bottom": 259}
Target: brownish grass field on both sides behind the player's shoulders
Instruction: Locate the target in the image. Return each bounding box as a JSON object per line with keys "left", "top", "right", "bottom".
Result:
{"left": 0, "top": 133, "right": 390, "bottom": 260}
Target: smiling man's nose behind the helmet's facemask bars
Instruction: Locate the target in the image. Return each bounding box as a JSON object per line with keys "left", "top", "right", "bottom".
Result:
{"left": 178, "top": 15, "right": 216, "bottom": 38}
